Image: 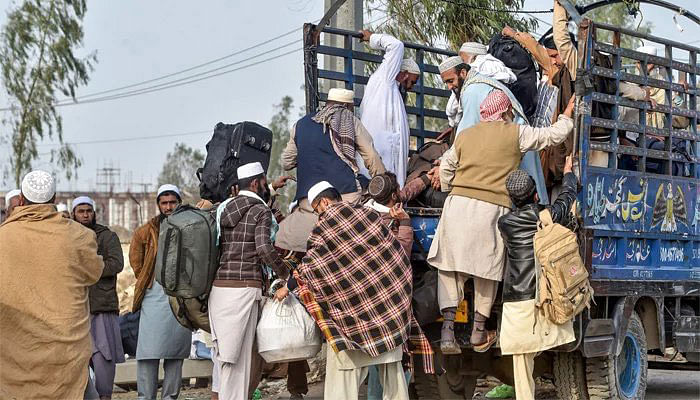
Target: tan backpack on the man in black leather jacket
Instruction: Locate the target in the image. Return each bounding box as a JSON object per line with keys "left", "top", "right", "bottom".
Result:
{"left": 534, "top": 209, "right": 593, "bottom": 324}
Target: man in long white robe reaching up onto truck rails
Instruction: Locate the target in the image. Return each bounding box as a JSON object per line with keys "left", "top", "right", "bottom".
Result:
{"left": 358, "top": 30, "right": 420, "bottom": 187}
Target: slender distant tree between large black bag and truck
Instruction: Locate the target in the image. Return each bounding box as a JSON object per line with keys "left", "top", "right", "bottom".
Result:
{"left": 267, "top": 96, "right": 296, "bottom": 211}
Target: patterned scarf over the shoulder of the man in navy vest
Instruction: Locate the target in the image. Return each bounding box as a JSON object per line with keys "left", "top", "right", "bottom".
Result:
{"left": 312, "top": 104, "right": 358, "bottom": 174}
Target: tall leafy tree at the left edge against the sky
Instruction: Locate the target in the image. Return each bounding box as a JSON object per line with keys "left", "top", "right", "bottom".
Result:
{"left": 0, "top": 0, "right": 97, "bottom": 185}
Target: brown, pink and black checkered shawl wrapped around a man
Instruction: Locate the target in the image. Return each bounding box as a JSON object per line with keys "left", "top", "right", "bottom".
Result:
{"left": 298, "top": 202, "right": 434, "bottom": 373}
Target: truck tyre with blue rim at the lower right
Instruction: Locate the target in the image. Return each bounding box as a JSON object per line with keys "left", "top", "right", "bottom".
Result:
{"left": 586, "top": 311, "right": 647, "bottom": 400}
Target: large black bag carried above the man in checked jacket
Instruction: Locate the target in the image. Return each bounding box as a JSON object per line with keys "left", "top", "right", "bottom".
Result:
{"left": 197, "top": 121, "right": 272, "bottom": 203}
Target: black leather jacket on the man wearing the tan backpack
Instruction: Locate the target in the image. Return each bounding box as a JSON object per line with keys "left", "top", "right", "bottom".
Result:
{"left": 498, "top": 173, "right": 577, "bottom": 302}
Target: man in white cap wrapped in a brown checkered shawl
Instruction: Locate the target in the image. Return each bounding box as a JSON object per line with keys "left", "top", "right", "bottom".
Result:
{"left": 297, "top": 182, "right": 432, "bottom": 399}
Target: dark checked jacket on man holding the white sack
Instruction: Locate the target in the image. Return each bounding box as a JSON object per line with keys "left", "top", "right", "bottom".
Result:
{"left": 214, "top": 195, "right": 289, "bottom": 286}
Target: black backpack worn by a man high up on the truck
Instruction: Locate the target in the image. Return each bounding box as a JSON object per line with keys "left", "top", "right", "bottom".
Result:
{"left": 489, "top": 33, "right": 537, "bottom": 120}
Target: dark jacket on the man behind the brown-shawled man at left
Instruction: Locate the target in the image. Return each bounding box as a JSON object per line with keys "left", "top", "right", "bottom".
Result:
{"left": 89, "top": 224, "right": 124, "bottom": 314}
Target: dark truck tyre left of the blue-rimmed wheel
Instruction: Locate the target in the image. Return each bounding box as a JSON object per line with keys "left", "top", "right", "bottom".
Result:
{"left": 552, "top": 351, "right": 588, "bottom": 400}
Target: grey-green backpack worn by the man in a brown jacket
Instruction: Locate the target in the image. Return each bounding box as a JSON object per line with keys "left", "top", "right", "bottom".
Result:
{"left": 155, "top": 205, "right": 219, "bottom": 332}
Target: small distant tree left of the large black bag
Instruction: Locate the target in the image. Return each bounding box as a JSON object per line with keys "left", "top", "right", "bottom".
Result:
{"left": 158, "top": 143, "right": 204, "bottom": 204}
